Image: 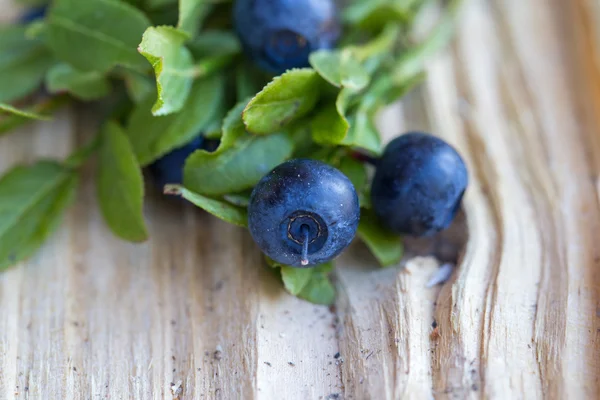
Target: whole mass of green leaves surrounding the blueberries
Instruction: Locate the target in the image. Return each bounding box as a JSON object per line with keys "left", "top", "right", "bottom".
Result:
{"left": 0, "top": 0, "right": 459, "bottom": 304}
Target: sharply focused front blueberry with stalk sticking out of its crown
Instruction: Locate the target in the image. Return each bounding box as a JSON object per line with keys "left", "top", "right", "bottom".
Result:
{"left": 248, "top": 159, "right": 360, "bottom": 267}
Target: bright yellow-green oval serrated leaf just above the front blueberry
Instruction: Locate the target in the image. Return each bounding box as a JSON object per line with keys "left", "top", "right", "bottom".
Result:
{"left": 243, "top": 68, "right": 320, "bottom": 134}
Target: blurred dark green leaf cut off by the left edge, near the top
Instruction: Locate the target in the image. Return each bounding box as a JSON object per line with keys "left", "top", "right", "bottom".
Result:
{"left": 0, "top": 25, "right": 53, "bottom": 102}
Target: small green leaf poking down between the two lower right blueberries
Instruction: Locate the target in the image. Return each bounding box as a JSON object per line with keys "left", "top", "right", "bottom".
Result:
{"left": 357, "top": 210, "right": 404, "bottom": 267}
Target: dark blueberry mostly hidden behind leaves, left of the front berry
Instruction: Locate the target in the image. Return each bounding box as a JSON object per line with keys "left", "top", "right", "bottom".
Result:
{"left": 148, "top": 136, "right": 205, "bottom": 190}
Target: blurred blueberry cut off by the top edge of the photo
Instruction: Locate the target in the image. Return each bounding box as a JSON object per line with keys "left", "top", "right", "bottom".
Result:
{"left": 233, "top": 0, "right": 340, "bottom": 74}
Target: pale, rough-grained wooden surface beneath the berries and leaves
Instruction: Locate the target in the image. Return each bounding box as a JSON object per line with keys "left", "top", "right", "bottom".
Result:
{"left": 0, "top": 0, "right": 600, "bottom": 399}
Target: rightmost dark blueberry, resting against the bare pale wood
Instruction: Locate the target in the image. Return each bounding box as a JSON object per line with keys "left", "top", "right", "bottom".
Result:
{"left": 371, "top": 132, "right": 468, "bottom": 236}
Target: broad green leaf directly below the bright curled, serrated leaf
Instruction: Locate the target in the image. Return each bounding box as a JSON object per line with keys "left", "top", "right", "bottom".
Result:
{"left": 127, "top": 75, "right": 225, "bottom": 166}
